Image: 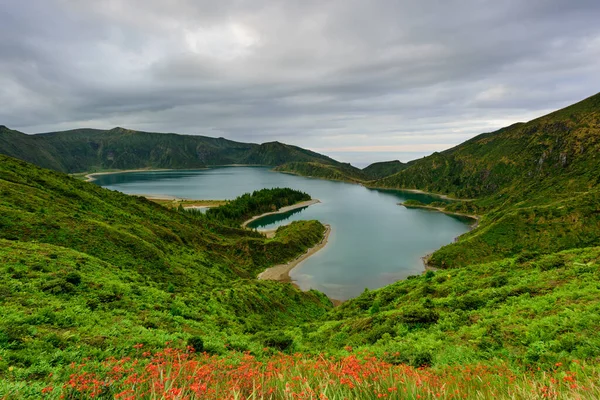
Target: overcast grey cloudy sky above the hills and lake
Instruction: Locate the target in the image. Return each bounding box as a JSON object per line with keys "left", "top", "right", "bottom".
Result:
{"left": 0, "top": 0, "right": 600, "bottom": 166}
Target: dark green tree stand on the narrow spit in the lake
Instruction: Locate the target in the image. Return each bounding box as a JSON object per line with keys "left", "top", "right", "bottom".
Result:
{"left": 206, "top": 188, "right": 310, "bottom": 226}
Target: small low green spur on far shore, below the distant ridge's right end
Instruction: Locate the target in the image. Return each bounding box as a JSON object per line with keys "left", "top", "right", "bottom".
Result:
{"left": 275, "top": 162, "right": 367, "bottom": 182}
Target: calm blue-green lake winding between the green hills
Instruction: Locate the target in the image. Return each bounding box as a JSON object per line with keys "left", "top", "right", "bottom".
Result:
{"left": 95, "top": 167, "right": 471, "bottom": 300}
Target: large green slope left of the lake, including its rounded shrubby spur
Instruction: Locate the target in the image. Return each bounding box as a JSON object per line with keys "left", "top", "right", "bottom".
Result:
{"left": 0, "top": 156, "right": 330, "bottom": 381}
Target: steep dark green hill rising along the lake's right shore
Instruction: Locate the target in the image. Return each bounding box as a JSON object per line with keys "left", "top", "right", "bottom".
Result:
{"left": 370, "top": 94, "right": 600, "bottom": 267}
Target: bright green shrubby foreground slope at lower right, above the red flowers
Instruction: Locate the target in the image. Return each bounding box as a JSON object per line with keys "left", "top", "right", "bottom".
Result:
{"left": 301, "top": 247, "right": 600, "bottom": 369}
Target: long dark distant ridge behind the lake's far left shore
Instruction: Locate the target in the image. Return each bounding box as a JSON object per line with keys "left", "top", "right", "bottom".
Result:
{"left": 0, "top": 126, "right": 341, "bottom": 173}
